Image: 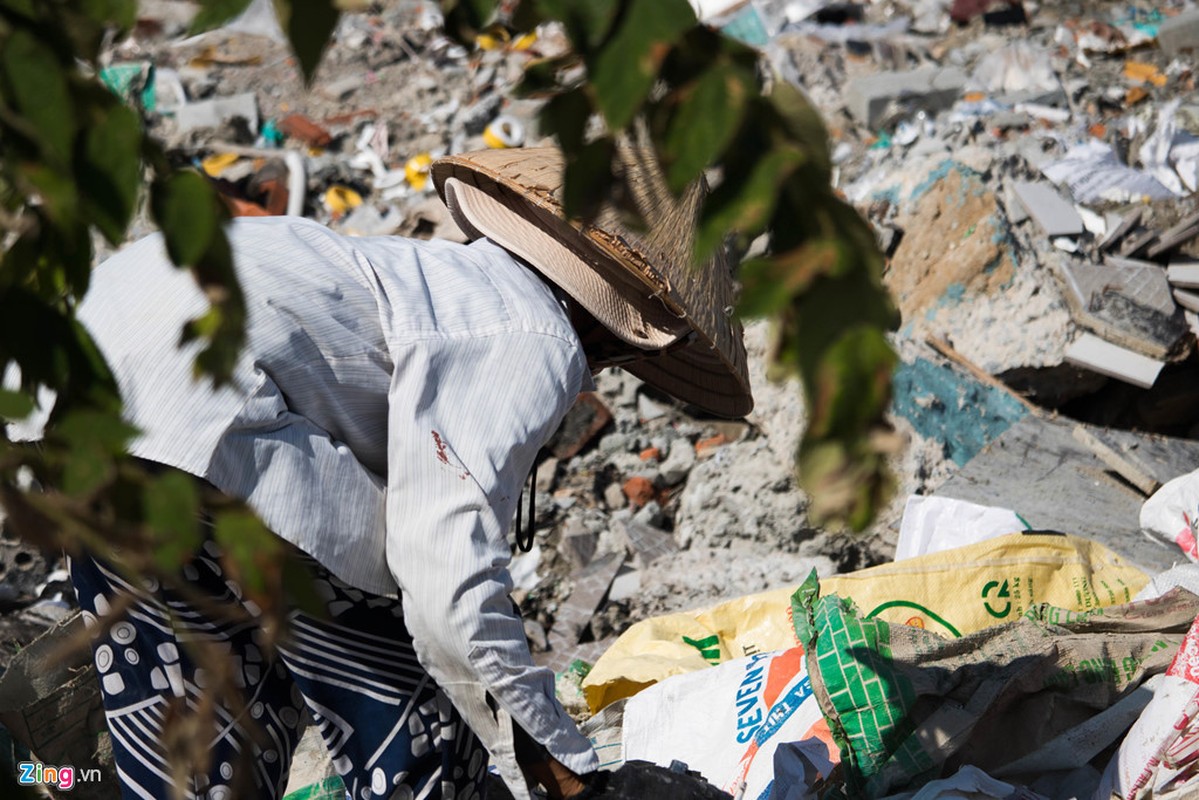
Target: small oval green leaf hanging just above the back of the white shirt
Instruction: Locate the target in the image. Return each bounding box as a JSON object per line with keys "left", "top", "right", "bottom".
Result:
{"left": 150, "top": 169, "right": 219, "bottom": 266}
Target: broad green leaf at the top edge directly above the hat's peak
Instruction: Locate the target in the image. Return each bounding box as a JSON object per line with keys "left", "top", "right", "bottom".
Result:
{"left": 588, "top": 0, "right": 695, "bottom": 131}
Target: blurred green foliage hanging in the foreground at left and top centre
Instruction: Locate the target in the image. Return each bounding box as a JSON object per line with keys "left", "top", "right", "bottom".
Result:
{"left": 0, "top": 0, "right": 894, "bottom": 642}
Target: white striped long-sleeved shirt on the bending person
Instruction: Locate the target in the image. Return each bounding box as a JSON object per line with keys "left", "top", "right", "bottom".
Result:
{"left": 70, "top": 217, "right": 596, "bottom": 788}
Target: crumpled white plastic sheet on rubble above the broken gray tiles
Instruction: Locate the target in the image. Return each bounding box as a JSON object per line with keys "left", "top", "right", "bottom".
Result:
{"left": 1041, "top": 139, "right": 1175, "bottom": 208}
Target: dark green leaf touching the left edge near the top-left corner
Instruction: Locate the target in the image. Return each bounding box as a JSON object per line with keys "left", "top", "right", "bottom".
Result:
{"left": 0, "top": 29, "right": 76, "bottom": 164}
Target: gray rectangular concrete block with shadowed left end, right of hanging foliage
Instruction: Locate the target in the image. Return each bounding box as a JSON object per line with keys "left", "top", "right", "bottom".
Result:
{"left": 845, "top": 66, "right": 966, "bottom": 130}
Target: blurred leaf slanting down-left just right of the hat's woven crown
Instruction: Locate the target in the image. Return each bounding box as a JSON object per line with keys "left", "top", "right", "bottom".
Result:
{"left": 695, "top": 144, "right": 805, "bottom": 263}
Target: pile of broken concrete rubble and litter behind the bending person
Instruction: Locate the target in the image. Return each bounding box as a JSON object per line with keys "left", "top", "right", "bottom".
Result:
{"left": 7, "top": 0, "right": 1199, "bottom": 791}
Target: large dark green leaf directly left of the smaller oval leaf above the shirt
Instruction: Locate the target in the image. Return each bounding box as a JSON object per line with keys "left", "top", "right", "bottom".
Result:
{"left": 76, "top": 104, "right": 141, "bottom": 245}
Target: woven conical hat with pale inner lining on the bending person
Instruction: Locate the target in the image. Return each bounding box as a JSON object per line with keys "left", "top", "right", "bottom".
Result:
{"left": 432, "top": 148, "right": 753, "bottom": 416}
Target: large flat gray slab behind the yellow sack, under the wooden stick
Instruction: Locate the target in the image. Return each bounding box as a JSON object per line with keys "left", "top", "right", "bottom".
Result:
{"left": 936, "top": 416, "right": 1199, "bottom": 572}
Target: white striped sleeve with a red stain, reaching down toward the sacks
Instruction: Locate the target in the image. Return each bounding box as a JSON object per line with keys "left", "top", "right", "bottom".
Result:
{"left": 386, "top": 331, "right": 597, "bottom": 796}
